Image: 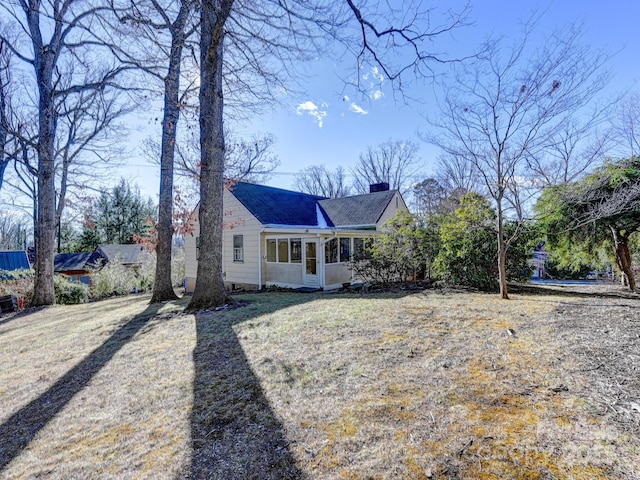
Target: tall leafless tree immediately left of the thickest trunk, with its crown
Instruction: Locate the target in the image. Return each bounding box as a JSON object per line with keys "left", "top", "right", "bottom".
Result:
{"left": 106, "top": 0, "right": 197, "bottom": 303}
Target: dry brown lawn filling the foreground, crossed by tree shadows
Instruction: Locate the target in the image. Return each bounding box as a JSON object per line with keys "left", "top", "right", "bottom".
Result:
{"left": 0, "top": 286, "right": 640, "bottom": 479}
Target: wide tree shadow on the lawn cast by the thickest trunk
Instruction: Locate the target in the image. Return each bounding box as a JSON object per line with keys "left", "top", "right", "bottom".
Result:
{"left": 191, "top": 294, "right": 317, "bottom": 480}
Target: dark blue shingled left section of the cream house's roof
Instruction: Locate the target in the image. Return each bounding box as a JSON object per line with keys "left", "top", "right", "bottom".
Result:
{"left": 230, "top": 182, "right": 333, "bottom": 227}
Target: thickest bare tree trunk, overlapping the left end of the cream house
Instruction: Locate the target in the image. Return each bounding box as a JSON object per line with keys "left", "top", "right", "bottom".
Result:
{"left": 187, "top": 0, "right": 233, "bottom": 310}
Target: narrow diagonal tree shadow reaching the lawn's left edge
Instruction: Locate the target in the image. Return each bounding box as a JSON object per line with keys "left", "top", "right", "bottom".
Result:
{"left": 0, "top": 304, "right": 170, "bottom": 472}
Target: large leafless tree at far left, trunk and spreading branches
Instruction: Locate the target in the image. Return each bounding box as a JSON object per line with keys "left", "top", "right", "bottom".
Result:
{"left": 0, "top": 0, "right": 132, "bottom": 305}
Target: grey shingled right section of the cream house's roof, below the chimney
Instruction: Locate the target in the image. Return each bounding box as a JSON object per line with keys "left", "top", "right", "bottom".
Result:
{"left": 318, "top": 190, "right": 396, "bottom": 227}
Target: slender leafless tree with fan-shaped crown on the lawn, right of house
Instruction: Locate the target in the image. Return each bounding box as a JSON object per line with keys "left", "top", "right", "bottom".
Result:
{"left": 424, "top": 17, "right": 608, "bottom": 298}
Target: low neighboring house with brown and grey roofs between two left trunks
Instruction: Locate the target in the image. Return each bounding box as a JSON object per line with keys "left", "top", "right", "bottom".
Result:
{"left": 53, "top": 245, "right": 153, "bottom": 285}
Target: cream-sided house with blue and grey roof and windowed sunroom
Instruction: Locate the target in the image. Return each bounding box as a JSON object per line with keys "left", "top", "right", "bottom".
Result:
{"left": 185, "top": 182, "right": 407, "bottom": 292}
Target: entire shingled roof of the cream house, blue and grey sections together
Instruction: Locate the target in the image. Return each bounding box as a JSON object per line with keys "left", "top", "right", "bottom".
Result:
{"left": 230, "top": 182, "right": 396, "bottom": 228}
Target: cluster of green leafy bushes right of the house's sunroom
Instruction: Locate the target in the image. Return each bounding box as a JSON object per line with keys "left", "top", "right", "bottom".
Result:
{"left": 353, "top": 193, "right": 537, "bottom": 291}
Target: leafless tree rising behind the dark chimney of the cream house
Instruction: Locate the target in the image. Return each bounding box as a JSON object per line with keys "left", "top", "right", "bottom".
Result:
{"left": 351, "top": 140, "right": 419, "bottom": 193}
